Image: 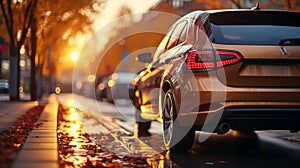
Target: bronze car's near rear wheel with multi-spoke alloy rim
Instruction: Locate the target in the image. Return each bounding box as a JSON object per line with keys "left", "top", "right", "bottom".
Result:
{"left": 162, "top": 89, "right": 195, "bottom": 152}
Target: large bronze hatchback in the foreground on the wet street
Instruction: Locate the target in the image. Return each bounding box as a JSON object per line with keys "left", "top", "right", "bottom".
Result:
{"left": 131, "top": 8, "right": 300, "bottom": 151}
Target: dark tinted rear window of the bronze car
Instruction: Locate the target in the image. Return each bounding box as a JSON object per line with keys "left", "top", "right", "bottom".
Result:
{"left": 211, "top": 11, "right": 300, "bottom": 45}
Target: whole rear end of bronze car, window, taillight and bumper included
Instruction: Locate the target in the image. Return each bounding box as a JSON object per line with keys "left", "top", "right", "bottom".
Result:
{"left": 182, "top": 10, "right": 300, "bottom": 131}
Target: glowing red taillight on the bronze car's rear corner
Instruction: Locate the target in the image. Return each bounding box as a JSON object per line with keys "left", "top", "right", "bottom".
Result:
{"left": 187, "top": 50, "right": 243, "bottom": 71}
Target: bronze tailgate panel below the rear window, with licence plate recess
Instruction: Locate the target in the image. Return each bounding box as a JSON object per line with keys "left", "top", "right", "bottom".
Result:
{"left": 215, "top": 44, "right": 300, "bottom": 87}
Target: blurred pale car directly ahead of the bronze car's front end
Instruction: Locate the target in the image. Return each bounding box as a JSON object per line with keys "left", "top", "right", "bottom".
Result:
{"left": 105, "top": 72, "right": 136, "bottom": 103}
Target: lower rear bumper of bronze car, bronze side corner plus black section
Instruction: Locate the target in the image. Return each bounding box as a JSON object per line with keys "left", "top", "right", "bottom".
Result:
{"left": 178, "top": 102, "right": 300, "bottom": 131}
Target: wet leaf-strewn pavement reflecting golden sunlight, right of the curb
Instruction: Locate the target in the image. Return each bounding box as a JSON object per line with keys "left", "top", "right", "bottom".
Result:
{"left": 58, "top": 106, "right": 155, "bottom": 167}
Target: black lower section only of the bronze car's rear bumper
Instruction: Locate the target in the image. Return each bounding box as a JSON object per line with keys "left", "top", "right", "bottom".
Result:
{"left": 221, "top": 107, "right": 300, "bottom": 131}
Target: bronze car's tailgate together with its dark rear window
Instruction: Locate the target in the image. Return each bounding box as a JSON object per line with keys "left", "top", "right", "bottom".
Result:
{"left": 211, "top": 11, "right": 300, "bottom": 88}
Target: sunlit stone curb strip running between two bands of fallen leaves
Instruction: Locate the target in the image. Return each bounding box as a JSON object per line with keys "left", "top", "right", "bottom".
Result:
{"left": 12, "top": 94, "right": 59, "bottom": 168}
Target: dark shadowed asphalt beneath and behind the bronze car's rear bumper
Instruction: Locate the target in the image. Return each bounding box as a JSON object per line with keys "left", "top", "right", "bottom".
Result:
{"left": 171, "top": 132, "right": 300, "bottom": 168}
